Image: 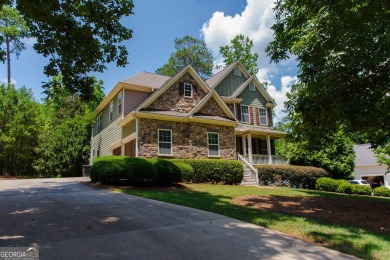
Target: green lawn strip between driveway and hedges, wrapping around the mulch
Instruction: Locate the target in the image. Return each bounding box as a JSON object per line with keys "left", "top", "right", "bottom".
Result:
{"left": 115, "top": 184, "right": 390, "bottom": 259}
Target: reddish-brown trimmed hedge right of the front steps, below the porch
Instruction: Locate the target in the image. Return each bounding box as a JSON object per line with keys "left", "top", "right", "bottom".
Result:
{"left": 255, "top": 165, "right": 328, "bottom": 189}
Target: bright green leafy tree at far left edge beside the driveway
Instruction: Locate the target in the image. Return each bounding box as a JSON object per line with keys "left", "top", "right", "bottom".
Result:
{"left": 0, "top": 84, "right": 43, "bottom": 176}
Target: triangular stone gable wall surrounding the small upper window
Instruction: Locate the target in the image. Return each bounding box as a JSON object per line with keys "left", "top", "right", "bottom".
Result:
{"left": 147, "top": 72, "right": 206, "bottom": 113}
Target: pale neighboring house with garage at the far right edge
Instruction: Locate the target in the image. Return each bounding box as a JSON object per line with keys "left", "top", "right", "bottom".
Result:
{"left": 354, "top": 144, "right": 390, "bottom": 188}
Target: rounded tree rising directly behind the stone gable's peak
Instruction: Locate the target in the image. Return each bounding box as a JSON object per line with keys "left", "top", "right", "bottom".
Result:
{"left": 156, "top": 35, "right": 213, "bottom": 79}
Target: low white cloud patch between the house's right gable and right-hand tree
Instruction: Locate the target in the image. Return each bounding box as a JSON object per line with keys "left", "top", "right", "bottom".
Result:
{"left": 267, "top": 76, "right": 298, "bottom": 122}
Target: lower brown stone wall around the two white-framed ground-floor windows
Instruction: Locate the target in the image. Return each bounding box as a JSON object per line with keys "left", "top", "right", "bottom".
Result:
{"left": 138, "top": 118, "right": 236, "bottom": 159}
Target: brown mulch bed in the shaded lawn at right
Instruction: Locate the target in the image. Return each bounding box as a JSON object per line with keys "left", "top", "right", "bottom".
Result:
{"left": 233, "top": 196, "right": 390, "bottom": 234}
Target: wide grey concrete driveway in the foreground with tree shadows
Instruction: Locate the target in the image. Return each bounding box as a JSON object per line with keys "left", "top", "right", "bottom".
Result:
{"left": 0, "top": 178, "right": 353, "bottom": 260}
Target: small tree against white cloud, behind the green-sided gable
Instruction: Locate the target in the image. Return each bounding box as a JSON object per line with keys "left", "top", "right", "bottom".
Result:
{"left": 219, "top": 34, "right": 259, "bottom": 75}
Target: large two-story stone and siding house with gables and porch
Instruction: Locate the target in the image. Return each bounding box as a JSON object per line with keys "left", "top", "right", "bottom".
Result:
{"left": 91, "top": 61, "right": 286, "bottom": 171}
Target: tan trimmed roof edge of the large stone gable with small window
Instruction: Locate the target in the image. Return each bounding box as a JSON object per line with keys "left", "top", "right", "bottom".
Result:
{"left": 135, "top": 65, "right": 210, "bottom": 112}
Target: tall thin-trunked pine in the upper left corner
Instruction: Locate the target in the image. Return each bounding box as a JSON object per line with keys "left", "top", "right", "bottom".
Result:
{"left": 0, "top": 5, "right": 28, "bottom": 83}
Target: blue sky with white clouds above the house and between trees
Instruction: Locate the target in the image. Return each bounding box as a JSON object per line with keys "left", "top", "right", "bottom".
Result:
{"left": 0, "top": 0, "right": 297, "bottom": 120}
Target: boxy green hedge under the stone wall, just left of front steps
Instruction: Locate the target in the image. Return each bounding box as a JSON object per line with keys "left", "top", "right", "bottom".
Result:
{"left": 171, "top": 159, "right": 244, "bottom": 185}
